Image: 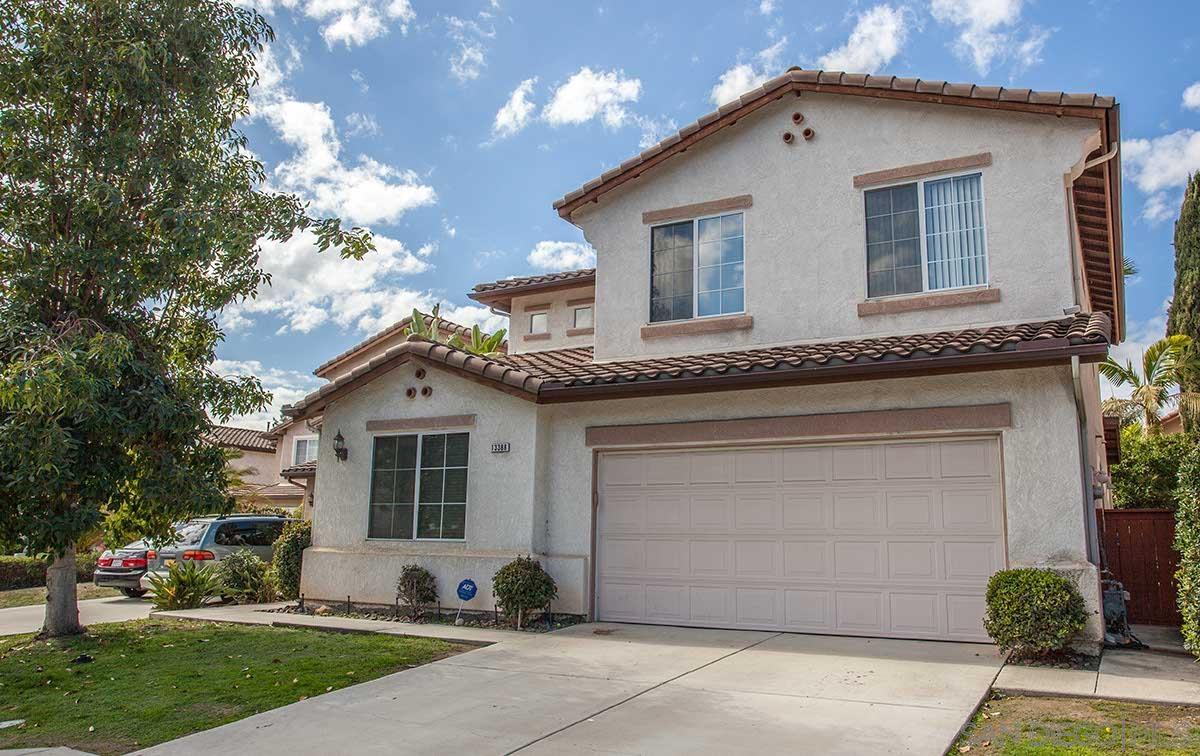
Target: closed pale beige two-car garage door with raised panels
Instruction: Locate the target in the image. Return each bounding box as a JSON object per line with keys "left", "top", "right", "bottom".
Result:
{"left": 595, "top": 438, "right": 1004, "bottom": 641}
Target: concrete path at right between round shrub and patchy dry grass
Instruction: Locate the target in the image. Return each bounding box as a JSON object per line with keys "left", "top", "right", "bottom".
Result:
{"left": 994, "top": 628, "right": 1200, "bottom": 706}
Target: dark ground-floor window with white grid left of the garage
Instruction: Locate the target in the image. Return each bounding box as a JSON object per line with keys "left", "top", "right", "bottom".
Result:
{"left": 367, "top": 433, "right": 470, "bottom": 540}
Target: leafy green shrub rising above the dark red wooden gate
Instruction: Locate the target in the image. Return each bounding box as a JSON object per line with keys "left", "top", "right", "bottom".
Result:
{"left": 1109, "top": 425, "right": 1195, "bottom": 509}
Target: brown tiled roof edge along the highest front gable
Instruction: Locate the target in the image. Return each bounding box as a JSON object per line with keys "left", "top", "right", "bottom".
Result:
{"left": 554, "top": 67, "right": 1116, "bottom": 217}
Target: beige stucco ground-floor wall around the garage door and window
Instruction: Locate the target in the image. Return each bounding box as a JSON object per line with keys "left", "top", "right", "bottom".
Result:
{"left": 302, "top": 366, "right": 1099, "bottom": 637}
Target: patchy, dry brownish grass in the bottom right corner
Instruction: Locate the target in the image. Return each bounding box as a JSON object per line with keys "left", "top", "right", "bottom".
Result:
{"left": 950, "top": 695, "right": 1200, "bottom": 756}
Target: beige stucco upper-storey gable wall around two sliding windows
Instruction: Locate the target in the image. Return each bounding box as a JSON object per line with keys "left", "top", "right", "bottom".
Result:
{"left": 574, "top": 94, "right": 1096, "bottom": 360}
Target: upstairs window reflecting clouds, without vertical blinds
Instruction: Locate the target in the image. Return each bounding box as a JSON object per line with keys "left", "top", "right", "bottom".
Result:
{"left": 650, "top": 212, "right": 745, "bottom": 323}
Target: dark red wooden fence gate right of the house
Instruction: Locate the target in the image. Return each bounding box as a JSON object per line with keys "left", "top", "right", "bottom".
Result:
{"left": 1096, "top": 509, "right": 1181, "bottom": 625}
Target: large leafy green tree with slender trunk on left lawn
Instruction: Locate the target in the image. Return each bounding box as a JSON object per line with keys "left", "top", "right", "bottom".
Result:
{"left": 0, "top": 0, "right": 371, "bottom": 635}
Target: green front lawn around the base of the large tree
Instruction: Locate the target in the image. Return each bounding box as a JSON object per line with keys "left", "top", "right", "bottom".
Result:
{"left": 0, "top": 619, "right": 464, "bottom": 754}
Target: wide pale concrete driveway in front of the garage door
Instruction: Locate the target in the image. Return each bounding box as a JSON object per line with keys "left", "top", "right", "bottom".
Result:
{"left": 143, "top": 624, "right": 1001, "bottom": 755}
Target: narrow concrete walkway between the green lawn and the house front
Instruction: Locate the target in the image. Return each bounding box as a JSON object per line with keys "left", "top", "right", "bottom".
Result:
{"left": 150, "top": 601, "right": 516, "bottom": 646}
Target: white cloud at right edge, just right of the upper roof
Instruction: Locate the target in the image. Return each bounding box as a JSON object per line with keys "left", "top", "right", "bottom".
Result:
{"left": 1121, "top": 128, "right": 1200, "bottom": 223}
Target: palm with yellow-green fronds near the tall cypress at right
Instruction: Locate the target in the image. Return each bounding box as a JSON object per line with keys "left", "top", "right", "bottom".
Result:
{"left": 1100, "top": 335, "right": 1200, "bottom": 433}
